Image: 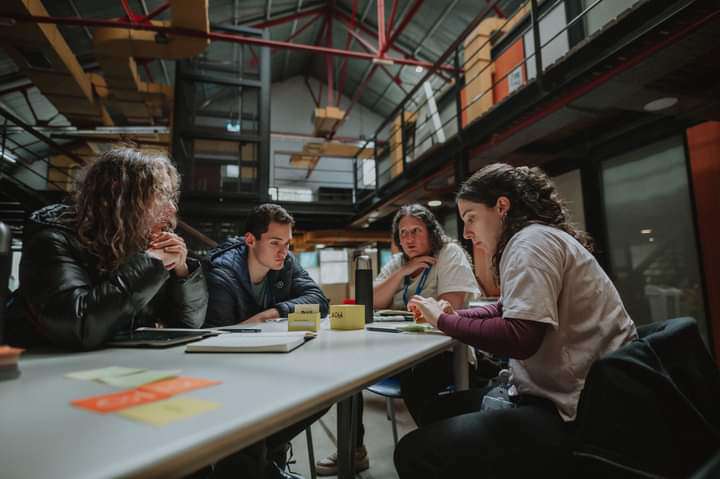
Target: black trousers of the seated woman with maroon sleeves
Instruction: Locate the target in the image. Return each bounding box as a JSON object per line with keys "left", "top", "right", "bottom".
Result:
{"left": 395, "top": 389, "right": 574, "bottom": 479}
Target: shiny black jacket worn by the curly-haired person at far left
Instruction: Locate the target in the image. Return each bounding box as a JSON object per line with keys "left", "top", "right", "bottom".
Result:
{"left": 5, "top": 205, "right": 208, "bottom": 350}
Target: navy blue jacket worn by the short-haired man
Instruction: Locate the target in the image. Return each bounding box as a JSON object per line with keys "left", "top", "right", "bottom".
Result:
{"left": 205, "top": 237, "right": 328, "bottom": 328}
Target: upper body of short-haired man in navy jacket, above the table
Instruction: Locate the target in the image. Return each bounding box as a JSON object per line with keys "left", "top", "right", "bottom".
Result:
{"left": 205, "top": 203, "right": 328, "bottom": 328}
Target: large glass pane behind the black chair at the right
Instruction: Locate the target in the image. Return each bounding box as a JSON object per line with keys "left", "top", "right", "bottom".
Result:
{"left": 602, "top": 137, "right": 708, "bottom": 342}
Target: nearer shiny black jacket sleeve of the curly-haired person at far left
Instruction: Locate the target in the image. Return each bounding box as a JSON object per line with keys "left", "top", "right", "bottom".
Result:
{"left": 21, "top": 230, "right": 169, "bottom": 349}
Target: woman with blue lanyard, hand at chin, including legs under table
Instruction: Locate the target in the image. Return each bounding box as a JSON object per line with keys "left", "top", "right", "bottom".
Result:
{"left": 316, "top": 204, "right": 480, "bottom": 476}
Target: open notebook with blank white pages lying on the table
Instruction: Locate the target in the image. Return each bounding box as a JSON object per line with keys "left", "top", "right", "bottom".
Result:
{"left": 185, "top": 331, "right": 315, "bottom": 353}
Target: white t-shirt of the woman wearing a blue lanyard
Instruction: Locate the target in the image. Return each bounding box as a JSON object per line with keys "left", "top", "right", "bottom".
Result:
{"left": 375, "top": 243, "right": 480, "bottom": 309}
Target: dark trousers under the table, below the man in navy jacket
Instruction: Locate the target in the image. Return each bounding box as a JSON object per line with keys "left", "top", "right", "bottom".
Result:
{"left": 209, "top": 409, "right": 328, "bottom": 479}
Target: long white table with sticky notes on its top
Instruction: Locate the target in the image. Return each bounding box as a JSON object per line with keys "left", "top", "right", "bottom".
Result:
{"left": 0, "top": 324, "right": 467, "bottom": 479}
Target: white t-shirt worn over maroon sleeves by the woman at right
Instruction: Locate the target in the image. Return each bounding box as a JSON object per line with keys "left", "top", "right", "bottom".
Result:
{"left": 500, "top": 225, "right": 637, "bottom": 421}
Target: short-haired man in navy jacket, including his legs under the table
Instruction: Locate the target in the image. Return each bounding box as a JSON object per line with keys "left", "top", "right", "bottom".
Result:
{"left": 205, "top": 204, "right": 329, "bottom": 479}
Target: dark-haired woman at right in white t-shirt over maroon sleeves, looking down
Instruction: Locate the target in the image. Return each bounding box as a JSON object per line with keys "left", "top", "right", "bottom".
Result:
{"left": 395, "top": 164, "right": 637, "bottom": 478}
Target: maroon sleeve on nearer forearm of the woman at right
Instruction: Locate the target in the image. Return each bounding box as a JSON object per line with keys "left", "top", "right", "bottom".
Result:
{"left": 438, "top": 308, "right": 547, "bottom": 359}
